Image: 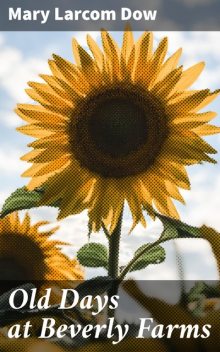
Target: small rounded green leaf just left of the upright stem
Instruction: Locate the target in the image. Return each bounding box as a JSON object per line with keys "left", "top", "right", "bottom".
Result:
{"left": 77, "top": 242, "right": 108, "bottom": 269}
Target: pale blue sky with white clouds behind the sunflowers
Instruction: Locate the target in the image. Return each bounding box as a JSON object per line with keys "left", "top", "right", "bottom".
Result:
{"left": 0, "top": 32, "right": 220, "bottom": 280}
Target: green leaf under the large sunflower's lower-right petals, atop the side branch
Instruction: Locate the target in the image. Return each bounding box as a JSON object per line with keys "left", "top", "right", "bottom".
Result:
{"left": 156, "top": 213, "right": 202, "bottom": 240}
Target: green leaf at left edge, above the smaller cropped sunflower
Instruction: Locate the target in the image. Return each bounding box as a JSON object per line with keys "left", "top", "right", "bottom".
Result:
{"left": 0, "top": 187, "right": 58, "bottom": 218}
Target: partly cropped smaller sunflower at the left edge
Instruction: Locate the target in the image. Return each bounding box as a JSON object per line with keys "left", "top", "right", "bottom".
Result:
{"left": 0, "top": 212, "right": 83, "bottom": 292}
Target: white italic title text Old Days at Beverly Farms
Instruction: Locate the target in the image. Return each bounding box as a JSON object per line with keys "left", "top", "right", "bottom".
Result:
{"left": 8, "top": 288, "right": 212, "bottom": 344}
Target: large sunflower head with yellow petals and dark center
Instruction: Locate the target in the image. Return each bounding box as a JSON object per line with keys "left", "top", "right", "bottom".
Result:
{"left": 16, "top": 30, "right": 219, "bottom": 232}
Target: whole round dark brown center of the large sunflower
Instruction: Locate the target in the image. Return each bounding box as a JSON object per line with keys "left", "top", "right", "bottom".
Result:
{"left": 68, "top": 86, "right": 168, "bottom": 178}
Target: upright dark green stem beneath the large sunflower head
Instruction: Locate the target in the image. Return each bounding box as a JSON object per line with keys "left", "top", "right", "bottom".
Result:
{"left": 108, "top": 211, "right": 123, "bottom": 318}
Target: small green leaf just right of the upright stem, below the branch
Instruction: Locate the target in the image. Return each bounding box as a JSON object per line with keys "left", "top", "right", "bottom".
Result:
{"left": 130, "top": 244, "right": 166, "bottom": 271}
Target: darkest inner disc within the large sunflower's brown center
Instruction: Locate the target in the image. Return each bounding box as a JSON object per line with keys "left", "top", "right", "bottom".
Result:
{"left": 89, "top": 98, "right": 148, "bottom": 157}
